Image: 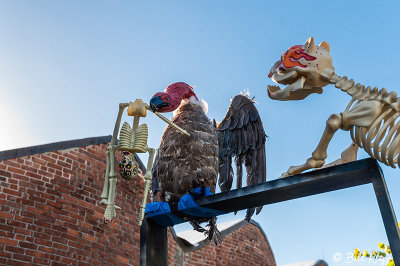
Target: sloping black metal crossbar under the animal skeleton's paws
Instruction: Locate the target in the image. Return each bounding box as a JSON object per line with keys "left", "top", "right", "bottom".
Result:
{"left": 197, "top": 158, "right": 380, "bottom": 212}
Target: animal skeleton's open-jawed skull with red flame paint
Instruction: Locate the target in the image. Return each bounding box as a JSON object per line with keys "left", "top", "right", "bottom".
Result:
{"left": 268, "top": 37, "right": 334, "bottom": 101}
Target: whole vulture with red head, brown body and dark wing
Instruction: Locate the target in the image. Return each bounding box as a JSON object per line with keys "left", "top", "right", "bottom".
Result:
{"left": 150, "top": 82, "right": 266, "bottom": 244}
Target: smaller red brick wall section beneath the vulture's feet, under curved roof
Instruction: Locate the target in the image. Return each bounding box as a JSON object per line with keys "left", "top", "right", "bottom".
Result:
{"left": 168, "top": 224, "right": 276, "bottom": 266}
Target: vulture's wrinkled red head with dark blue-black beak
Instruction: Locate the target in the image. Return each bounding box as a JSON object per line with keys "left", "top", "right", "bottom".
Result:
{"left": 150, "top": 82, "right": 197, "bottom": 113}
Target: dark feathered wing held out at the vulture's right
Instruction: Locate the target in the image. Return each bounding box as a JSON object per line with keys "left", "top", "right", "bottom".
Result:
{"left": 217, "top": 95, "right": 266, "bottom": 220}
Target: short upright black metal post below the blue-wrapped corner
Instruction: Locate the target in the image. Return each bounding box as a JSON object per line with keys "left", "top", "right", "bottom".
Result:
{"left": 140, "top": 217, "right": 168, "bottom": 266}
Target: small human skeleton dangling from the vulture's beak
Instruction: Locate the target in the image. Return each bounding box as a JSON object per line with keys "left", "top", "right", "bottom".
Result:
{"left": 101, "top": 99, "right": 189, "bottom": 226}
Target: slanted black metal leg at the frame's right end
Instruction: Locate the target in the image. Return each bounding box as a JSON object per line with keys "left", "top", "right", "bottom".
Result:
{"left": 372, "top": 169, "right": 400, "bottom": 265}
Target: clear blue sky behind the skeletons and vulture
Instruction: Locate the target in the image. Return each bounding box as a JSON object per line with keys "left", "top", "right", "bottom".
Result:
{"left": 0, "top": 0, "right": 400, "bottom": 265}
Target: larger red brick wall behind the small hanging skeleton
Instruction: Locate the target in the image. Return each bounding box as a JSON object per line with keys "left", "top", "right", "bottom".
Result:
{"left": 0, "top": 144, "right": 143, "bottom": 265}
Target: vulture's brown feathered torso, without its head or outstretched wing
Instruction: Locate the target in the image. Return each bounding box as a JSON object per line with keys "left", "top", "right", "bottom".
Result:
{"left": 153, "top": 100, "right": 218, "bottom": 196}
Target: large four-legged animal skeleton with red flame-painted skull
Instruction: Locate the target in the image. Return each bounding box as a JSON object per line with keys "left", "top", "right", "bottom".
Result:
{"left": 268, "top": 37, "right": 400, "bottom": 177}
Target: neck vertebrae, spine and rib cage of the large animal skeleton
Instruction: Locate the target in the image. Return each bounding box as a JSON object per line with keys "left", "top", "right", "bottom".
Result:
{"left": 329, "top": 74, "right": 400, "bottom": 168}
